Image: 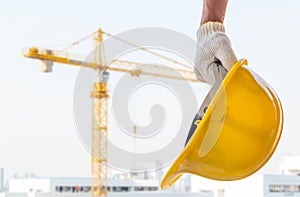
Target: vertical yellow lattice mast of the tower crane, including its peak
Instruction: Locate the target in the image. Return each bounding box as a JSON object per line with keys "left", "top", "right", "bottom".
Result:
{"left": 91, "top": 29, "right": 109, "bottom": 197}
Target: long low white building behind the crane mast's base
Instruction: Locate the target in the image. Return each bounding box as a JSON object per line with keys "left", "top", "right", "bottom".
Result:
{"left": 5, "top": 177, "right": 214, "bottom": 197}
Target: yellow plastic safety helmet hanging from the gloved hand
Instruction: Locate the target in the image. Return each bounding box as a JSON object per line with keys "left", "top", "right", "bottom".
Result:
{"left": 161, "top": 60, "right": 283, "bottom": 189}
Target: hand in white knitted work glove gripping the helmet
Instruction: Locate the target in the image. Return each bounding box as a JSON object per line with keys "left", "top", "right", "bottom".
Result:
{"left": 194, "top": 22, "right": 237, "bottom": 85}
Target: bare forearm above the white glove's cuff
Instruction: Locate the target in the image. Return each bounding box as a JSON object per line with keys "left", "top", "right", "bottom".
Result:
{"left": 201, "top": 0, "right": 228, "bottom": 25}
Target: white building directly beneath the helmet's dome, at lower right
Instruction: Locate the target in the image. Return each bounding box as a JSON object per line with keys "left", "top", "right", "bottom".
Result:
{"left": 196, "top": 174, "right": 300, "bottom": 197}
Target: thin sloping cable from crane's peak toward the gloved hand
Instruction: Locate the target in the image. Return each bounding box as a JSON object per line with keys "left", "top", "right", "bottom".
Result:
{"left": 102, "top": 31, "right": 192, "bottom": 69}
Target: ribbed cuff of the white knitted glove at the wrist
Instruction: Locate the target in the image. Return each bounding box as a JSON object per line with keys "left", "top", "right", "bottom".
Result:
{"left": 197, "top": 22, "right": 225, "bottom": 42}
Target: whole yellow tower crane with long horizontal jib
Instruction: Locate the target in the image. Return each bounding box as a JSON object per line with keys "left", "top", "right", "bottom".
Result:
{"left": 23, "top": 29, "right": 198, "bottom": 197}
